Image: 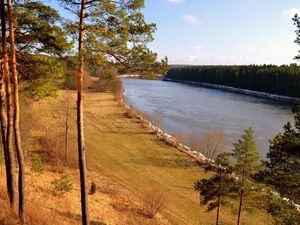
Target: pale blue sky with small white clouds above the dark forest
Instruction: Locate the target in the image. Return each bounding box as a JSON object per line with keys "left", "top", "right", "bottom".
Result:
{"left": 143, "top": 0, "right": 300, "bottom": 64}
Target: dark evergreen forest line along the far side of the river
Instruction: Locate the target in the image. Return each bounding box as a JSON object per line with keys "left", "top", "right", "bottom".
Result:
{"left": 166, "top": 64, "right": 300, "bottom": 97}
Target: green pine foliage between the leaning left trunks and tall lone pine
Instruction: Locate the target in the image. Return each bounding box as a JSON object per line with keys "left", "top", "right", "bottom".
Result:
{"left": 13, "top": 1, "right": 73, "bottom": 100}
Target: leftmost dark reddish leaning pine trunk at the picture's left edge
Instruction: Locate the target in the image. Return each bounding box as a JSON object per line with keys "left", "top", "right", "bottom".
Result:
{"left": 1, "top": 0, "right": 15, "bottom": 206}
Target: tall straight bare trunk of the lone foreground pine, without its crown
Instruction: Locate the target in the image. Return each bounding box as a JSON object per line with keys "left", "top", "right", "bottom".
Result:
{"left": 77, "top": 0, "right": 89, "bottom": 225}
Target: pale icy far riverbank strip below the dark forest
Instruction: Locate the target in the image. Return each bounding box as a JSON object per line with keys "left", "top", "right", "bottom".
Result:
{"left": 163, "top": 78, "right": 299, "bottom": 104}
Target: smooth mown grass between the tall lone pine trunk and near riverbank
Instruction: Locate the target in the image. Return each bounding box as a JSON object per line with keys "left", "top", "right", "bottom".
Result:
{"left": 74, "top": 90, "right": 271, "bottom": 225}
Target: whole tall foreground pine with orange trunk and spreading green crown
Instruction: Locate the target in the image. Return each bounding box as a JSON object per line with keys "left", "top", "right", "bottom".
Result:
{"left": 56, "top": 0, "right": 167, "bottom": 225}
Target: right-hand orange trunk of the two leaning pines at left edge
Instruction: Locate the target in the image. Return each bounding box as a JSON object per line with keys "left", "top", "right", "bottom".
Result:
{"left": 7, "top": 0, "right": 25, "bottom": 223}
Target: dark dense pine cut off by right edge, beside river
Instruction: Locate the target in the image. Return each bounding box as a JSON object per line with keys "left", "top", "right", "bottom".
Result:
{"left": 261, "top": 105, "right": 300, "bottom": 204}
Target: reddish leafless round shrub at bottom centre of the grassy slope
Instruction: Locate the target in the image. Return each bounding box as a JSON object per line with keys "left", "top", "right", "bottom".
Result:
{"left": 142, "top": 190, "right": 166, "bottom": 219}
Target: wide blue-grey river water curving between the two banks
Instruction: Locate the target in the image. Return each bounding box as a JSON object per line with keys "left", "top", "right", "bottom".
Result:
{"left": 122, "top": 78, "right": 293, "bottom": 158}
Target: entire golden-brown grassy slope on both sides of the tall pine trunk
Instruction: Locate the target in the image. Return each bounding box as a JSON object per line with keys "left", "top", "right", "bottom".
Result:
{"left": 0, "top": 88, "right": 272, "bottom": 225}
